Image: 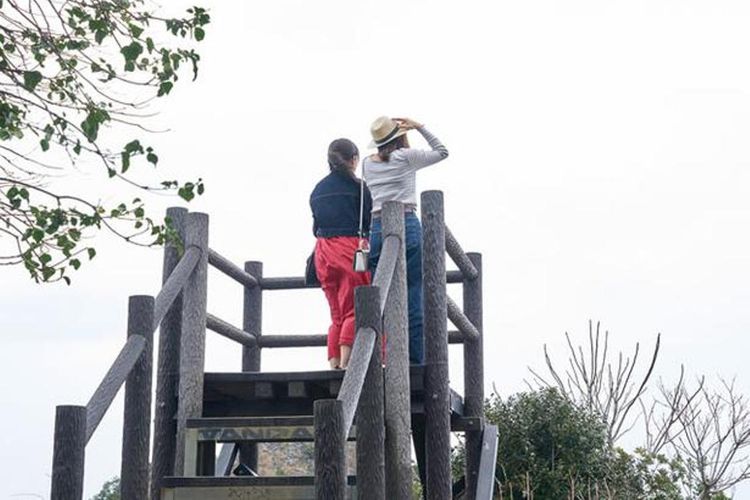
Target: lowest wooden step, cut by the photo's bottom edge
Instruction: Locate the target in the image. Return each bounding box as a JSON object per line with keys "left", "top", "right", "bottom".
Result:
{"left": 161, "top": 476, "right": 357, "bottom": 500}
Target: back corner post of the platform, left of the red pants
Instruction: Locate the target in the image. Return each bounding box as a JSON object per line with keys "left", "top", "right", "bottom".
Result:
{"left": 240, "top": 261, "right": 263, "bottom": 470}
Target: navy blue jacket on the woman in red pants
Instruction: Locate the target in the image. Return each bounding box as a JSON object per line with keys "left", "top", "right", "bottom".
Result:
{"left": 310, "top": 171, "right": 372, "bottom": 238}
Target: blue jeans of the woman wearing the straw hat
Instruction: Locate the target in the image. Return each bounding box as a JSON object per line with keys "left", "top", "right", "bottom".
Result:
{"left": 370, "top": 213, "right": 424, "bottom": 365}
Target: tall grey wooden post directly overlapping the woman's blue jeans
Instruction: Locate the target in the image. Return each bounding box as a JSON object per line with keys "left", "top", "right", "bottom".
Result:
{"left": 384, "top": 201, "right": 412, "bottom": 500}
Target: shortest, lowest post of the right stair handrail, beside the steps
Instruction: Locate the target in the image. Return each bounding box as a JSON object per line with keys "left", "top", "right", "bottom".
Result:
{"left": 314, "top": 399, "right": 346, "bottom": 500}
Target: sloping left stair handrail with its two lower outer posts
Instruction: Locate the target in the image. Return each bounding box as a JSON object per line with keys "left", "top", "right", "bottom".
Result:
{"left": 50, "top": 209, "right": 207, "bottom": 500}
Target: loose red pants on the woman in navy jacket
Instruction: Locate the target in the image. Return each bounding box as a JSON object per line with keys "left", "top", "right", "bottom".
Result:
{"left": 315, "top": 236, "right": 370, "bottom": 359}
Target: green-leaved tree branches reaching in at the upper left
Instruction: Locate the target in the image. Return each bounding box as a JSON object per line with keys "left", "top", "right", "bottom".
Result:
{"left": 0, "top": 0, "right": 210, "bottom": 282}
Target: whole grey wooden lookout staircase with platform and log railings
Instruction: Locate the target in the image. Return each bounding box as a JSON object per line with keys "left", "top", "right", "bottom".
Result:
{"left": 50, "top": 191, "right": 497, "bottom": 500}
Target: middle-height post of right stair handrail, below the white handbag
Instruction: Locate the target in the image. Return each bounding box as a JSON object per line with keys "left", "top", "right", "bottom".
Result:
{"left": 354, "top": 286, "right": 385, "bottom": 500}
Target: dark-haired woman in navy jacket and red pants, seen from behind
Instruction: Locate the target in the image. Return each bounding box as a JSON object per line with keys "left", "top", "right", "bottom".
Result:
{"left": 310, "top": 139, "right": 372, "bottom": 369}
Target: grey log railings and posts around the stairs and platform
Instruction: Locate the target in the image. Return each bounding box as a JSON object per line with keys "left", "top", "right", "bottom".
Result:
{"left": 51, "top": 191, "right": 494, "bottom": 500}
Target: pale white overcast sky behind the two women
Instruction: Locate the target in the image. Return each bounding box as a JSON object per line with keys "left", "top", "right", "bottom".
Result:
{"left": 0, "top": 0, "right": 750, "bottom": 499}
